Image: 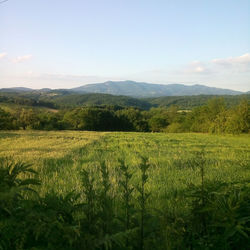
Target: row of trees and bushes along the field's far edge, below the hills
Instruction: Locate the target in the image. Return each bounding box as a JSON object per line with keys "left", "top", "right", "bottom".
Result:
{"left": 0, "top": 98, "right": 250, "bottom": 134}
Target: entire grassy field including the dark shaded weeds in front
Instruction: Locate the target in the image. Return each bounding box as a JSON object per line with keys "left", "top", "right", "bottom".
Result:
{"left": 0, "top": 131, "right": 250, "bottom": 249}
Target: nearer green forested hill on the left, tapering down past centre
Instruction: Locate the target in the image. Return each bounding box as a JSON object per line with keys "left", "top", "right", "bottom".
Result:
{"left": 0, "top": 90, "right": 152, "bottom": 109}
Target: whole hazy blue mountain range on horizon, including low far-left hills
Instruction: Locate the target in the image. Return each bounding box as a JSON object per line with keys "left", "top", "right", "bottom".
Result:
{"left": 0, "top": 81, "right": 246, "bottom": 98}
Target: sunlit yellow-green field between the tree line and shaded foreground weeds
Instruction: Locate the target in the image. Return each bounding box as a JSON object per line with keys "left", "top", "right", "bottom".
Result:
{"left": 0, "top": 131, "right": 250, "bottom": 195}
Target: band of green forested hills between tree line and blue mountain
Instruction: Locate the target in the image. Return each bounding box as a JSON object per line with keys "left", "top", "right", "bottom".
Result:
{"left": 0, "top": 90, "right": 250, "bottom": 110}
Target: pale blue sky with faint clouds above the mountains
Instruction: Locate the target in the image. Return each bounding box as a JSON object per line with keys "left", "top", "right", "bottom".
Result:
{"left": 0, "top": 0, "right": 250, "bottom": 91}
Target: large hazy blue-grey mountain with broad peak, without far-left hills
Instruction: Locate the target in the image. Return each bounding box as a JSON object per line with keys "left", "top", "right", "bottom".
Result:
{"left": 71, "top": 81, "right": 242, "bottom": 98}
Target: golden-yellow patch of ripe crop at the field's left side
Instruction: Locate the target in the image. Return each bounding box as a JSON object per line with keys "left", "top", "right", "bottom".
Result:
{"left": 0, "top": 131, "right": 104, "bottom": 160}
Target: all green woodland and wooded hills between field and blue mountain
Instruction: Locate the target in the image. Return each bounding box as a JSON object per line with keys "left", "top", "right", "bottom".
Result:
{"left": 0, "top": 92, "right": 250, "bottom": 133}
